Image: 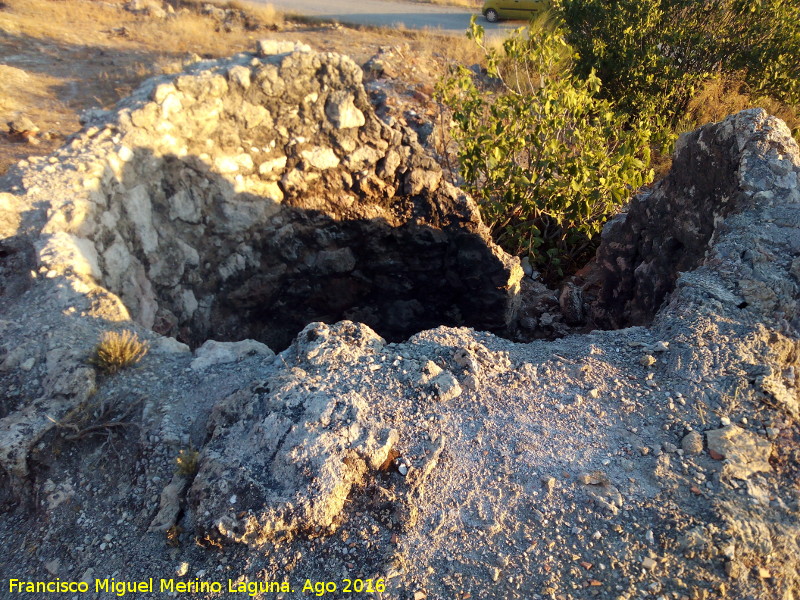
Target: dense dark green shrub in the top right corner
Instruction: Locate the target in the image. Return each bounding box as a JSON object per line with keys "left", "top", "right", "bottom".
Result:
{"left": 555, "top": 0, "right": 800, "bottom": 124}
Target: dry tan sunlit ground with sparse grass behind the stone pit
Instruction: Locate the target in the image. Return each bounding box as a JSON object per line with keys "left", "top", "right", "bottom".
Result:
{"left": 0, "top": 0, "right": 479, "bottom": 175}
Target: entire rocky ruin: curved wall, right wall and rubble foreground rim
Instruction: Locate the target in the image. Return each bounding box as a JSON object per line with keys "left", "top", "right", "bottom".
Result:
{"left": 0, "top": 42, "right": 800, "bottom": 599}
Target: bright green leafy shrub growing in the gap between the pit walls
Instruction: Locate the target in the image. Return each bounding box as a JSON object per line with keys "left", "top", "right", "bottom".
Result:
{"left": 437, "top": 19, "right": 652, "bottom": 276}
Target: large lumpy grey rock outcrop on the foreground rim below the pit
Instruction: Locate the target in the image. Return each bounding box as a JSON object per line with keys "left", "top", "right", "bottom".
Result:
{"left": 188, "top": 329, "right": 398, "bottom": 546}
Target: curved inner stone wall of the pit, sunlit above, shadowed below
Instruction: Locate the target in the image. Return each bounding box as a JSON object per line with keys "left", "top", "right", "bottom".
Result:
{"left": 67, "top": 42, "right": 522, "bottom": 350}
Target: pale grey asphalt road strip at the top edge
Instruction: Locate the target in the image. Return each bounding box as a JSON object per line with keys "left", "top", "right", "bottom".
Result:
{"left": 260, "top": 0, "right": 522, "bottom": 37}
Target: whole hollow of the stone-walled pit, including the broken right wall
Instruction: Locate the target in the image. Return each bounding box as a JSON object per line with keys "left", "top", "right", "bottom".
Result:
{"left": 14, "top": 41, "right": 791, "bottom": 360}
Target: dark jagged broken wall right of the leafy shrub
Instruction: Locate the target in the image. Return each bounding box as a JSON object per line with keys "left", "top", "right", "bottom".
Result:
{"left": 592, "top": 109, "right": 800, "bottom": 329}
